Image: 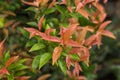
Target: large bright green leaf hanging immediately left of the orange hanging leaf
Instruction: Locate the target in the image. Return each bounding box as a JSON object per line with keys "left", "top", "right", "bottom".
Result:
{"left": 39, "top": 53, "right": 52, "bottom": 69}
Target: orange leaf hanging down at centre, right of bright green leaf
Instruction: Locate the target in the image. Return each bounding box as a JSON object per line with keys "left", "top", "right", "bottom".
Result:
{"left": 52, "top": 46, "right": 62, "bottom": 65}
